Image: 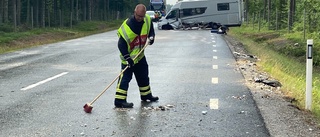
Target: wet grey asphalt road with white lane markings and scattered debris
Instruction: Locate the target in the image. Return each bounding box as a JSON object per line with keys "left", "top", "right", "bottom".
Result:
{"left": 0, "top": 24, "right": 270, "bottom": 137}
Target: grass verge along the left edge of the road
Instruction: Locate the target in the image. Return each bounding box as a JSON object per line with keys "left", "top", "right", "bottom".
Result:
{"left": 0, "top": 20, "right": 122, "bottom": 54}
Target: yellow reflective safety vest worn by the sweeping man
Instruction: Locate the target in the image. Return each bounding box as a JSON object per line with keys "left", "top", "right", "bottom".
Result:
{"left": 118, "top": 14, "right": 152, "bottom": 64}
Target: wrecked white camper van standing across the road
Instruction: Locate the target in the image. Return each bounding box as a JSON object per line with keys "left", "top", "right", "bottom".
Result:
{"left": 158, "top": 0, "right": 243, "bottom": 30}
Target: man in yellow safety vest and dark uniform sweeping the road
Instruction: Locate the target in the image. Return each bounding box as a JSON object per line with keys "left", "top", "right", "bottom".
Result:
{"left": 114, "top": 4, "right": 159, "bottom": 108}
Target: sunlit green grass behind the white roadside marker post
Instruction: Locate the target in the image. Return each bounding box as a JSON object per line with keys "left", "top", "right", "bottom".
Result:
{"left": 229, "top": 26, "right": 320, "bottom": 119}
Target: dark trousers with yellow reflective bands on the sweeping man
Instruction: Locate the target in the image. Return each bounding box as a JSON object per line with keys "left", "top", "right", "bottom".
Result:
{"left": 115, "top": 57, "right": 152, "bottom": 100}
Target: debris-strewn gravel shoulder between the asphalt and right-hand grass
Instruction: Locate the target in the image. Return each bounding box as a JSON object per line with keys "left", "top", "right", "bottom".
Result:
{"left": 224, "top": 35, "right": 320, "bottom": 137}
